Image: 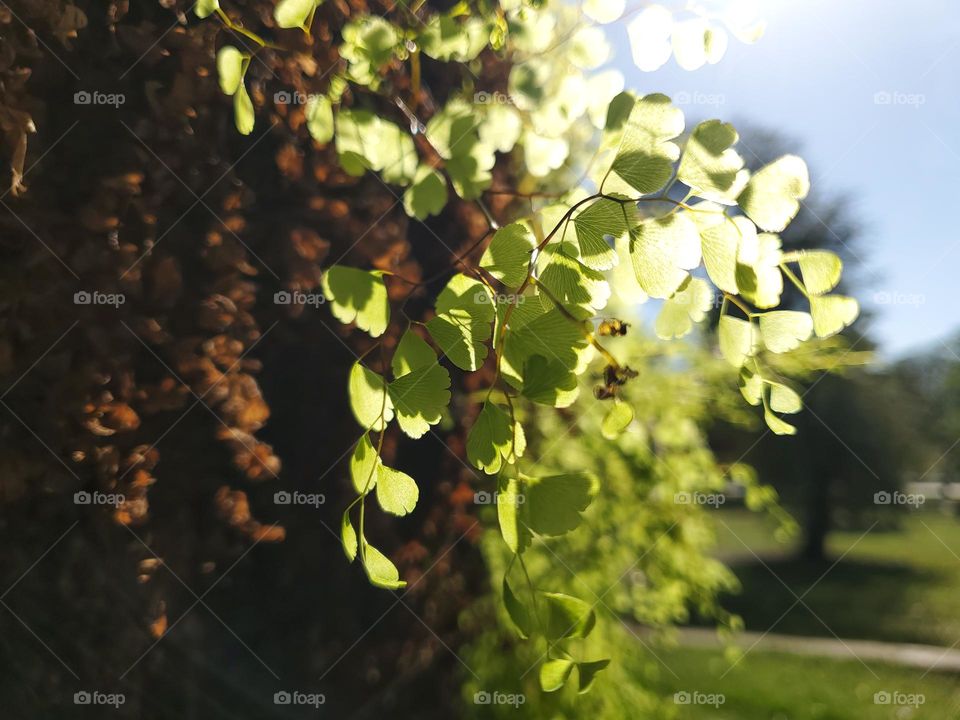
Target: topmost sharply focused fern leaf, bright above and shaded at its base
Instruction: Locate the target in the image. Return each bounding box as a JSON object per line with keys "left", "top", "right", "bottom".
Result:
{"left": 601, "top": 94, "right": 684, "bottom": 196}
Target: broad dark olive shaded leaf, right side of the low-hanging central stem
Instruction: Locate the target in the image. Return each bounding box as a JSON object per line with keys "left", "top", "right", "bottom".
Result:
{"left": 526, "top": 473, "right": 597, "bottom": 535}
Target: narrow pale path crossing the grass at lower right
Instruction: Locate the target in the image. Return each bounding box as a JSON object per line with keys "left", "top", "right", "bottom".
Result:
{"left": 679, "top": 628, "right": 960, "bottom": 673}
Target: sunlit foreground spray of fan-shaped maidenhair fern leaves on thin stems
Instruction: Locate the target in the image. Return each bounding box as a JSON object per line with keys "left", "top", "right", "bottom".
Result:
{"left": 191, "top": 0, "right": 858, "bottom": 691}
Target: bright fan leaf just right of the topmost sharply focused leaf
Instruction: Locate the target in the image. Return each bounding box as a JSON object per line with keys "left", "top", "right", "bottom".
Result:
{"left": 677, "top": 120, "right": 746, "bottom": 199}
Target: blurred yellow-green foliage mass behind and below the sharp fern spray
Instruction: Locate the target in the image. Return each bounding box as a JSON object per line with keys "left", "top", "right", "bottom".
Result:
{"left": 463, "top": 336, "right": 795, "bottom": 718}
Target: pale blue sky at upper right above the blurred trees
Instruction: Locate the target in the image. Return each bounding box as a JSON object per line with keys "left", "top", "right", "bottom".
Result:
{"left": 608, "top": 0, "right": 960, "bottom": 358}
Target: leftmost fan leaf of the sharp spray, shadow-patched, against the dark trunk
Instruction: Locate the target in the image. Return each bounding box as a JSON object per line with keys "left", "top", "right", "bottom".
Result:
{"left": 322, "top": 265, "right": 390, "bottom": 337}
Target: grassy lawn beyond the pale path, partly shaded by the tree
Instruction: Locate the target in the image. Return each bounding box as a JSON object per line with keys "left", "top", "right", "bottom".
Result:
{"left": 716, "top": 510, "right": 960, "bottom": 646}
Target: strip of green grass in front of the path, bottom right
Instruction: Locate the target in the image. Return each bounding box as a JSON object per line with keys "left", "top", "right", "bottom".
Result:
{"left": 656, "top": 648, "right": 960, "bottom": 720}
